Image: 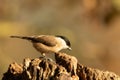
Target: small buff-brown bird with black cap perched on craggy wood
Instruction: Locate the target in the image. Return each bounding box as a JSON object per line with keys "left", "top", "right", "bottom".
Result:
{"left": 10, "top": 35, "right": 71, "bottom": 56}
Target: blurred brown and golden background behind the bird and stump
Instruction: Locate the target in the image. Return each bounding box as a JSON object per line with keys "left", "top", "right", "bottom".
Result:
{"left": 0, "top": 0, "right": 120, "bottom": 77}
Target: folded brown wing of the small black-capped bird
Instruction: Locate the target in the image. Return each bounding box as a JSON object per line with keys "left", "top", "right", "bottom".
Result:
{"left": 33, "top": 35, "right": 57, "bottom": 46}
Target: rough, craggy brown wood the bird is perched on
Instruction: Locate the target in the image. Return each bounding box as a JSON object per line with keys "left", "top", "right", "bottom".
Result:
{"left": 2, "top": 53, "right": 120, "bottom": 80}
